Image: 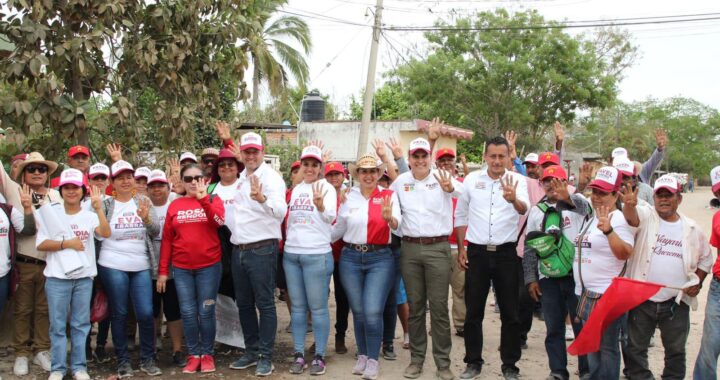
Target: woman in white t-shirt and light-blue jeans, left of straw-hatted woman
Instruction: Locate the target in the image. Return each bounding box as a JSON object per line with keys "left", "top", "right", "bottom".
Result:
{"left": 283, "top": 145, "right": 337, "bottom": 375}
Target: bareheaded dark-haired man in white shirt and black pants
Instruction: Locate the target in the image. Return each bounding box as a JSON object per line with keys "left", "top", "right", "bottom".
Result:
{"left": 455, "top": 136, "right": 530, "bottom": 379}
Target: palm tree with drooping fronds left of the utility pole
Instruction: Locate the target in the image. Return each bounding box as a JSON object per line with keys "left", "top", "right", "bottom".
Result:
{"left": 246, "top": 0, "right": 312, "bottom": 109}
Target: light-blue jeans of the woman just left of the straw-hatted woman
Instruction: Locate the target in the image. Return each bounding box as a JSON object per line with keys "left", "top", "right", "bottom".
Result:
{"left": 283, "top": 251, "right": 334, "bottom": 357}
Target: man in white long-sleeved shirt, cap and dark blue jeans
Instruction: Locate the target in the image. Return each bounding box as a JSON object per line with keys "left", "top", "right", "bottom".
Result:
{"left": 227, "top": 132, "right": 287, "bottom": 376}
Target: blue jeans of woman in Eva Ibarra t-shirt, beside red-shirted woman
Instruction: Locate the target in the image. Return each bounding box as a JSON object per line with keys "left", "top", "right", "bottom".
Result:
{"left": 98, "top": 265, "right": 155, "bottom": 366}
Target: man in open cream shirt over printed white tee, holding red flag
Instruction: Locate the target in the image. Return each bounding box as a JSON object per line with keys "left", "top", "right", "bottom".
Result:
{"left": 623, "top": 175, "right": 712, "bottom": 379}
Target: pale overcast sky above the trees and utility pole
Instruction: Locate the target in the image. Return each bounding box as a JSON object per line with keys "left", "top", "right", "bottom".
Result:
{"left": 272, "top": 0, "right": 720, "bottom": 116}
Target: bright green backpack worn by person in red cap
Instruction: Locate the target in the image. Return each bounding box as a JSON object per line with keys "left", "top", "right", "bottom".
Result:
{"left": 525, "top": 202, "right": 575, "bottom": 278}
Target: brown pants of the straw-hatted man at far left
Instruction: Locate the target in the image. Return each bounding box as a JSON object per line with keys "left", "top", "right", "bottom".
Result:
{"left": 13, "top": 262, "right": 50, "bottom": 357}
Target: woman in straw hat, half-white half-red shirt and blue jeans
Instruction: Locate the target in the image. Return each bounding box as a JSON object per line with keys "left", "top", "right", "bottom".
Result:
{"left": 333, "top": 154, "right": 402, "bottom": 379}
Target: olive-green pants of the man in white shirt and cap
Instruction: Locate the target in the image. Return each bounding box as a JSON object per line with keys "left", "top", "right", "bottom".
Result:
{"left": 400, "top": 241, "right": 452, "bottom": 368}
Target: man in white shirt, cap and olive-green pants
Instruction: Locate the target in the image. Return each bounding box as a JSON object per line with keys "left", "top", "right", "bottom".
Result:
{"left": 390, "top": 138, "right": 462, "bottom": 380}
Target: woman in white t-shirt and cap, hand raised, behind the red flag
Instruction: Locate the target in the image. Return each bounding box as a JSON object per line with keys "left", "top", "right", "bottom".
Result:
{"left": 573, "top": 166, "right": 634, "bottom": 379}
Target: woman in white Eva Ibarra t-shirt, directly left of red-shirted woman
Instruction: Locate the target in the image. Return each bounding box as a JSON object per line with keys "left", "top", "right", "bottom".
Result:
{"left": 98, "top": 160, "right": 162, "bottom": 378}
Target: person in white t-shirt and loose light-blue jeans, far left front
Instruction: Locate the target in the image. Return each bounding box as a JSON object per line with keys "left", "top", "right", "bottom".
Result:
{"left": 36, "top": 169, "right": 110, "bottom": 380}
